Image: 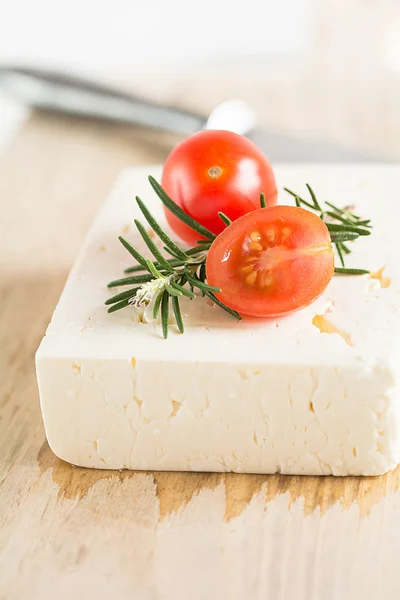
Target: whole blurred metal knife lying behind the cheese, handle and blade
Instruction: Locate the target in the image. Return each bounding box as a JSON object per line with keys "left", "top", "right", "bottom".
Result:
{"left": 0, "top": 65, "right": 377, "bottom": 162}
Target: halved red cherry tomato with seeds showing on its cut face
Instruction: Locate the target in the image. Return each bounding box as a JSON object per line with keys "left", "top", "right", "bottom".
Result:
{"left": 207, "top": 206, "right": 334, "bottom": 317}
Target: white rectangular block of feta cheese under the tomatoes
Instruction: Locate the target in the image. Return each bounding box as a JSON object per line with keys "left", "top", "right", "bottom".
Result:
{"left": 36, "top": 165, "right": 400, "bottom": 475}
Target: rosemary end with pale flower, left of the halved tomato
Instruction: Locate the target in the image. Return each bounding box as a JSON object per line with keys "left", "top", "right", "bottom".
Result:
{"left": 106, "top": 177, "right": 241, "bottom": 338}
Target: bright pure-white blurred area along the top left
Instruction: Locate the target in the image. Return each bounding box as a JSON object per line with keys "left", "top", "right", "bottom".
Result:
{"left": 0, "top": 0, "right": 316, "bottom": 72}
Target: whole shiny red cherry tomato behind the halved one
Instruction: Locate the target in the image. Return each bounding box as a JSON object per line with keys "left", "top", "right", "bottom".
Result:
{"left": 161, "top": 130, "right": 277, "bottom": 244}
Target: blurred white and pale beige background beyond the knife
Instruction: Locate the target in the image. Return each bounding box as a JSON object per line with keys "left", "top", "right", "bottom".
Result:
{"left": 0, "top": 0, "right": 400, "bottom": 158}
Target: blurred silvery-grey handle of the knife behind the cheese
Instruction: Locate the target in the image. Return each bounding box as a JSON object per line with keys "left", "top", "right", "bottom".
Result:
{"left": 0, "top": 66, "right": 206, "bottom": 135}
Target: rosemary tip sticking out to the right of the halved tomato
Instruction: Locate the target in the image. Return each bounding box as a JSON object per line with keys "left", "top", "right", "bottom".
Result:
{"left": 283, "top": 183, "right": 372, "bottom": 275}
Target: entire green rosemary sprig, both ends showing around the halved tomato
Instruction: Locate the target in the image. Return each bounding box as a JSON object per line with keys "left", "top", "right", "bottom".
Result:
{"left": 105, "top": 176, "right": 371, "bottom": 338}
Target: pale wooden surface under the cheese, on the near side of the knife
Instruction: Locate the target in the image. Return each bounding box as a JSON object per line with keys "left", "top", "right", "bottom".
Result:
{"left": 0, "top": 116, "right": 400, "bottom": 600}
